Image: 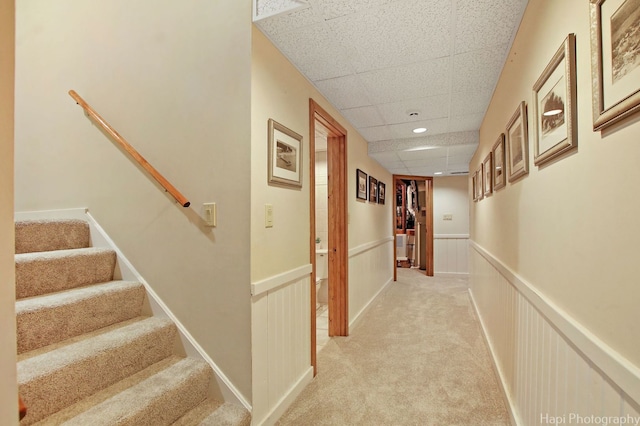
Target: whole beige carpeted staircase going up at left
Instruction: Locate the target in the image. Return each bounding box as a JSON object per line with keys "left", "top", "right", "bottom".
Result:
{"left": 15, "top": 219, "right": 250, "bottom": 426}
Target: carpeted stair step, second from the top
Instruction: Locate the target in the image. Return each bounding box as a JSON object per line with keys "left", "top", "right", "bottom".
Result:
{"left": 15, "top": 247, "right": 116, "bottom": 299}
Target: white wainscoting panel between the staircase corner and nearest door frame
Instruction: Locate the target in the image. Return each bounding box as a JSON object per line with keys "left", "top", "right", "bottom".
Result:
{"left": 251, "top": 264, "right": 313, "bottom": 425}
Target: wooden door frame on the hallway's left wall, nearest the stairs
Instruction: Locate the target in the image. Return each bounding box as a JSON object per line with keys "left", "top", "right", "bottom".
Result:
{"left": 309, "top": 99, "right": 349, "bottom": 375}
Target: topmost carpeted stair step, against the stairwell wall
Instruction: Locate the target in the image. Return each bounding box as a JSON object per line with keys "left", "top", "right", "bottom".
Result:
{"left": 16, "top": 219, "right": 90, "bottom": 253}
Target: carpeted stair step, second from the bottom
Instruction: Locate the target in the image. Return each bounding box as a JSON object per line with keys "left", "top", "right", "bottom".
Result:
{"left": 58, "top": 358, "right": 213, "bottom": 426}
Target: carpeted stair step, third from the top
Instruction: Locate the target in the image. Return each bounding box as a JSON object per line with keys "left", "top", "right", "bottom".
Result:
{"left": 16, "top": 281, "right": 145, "bottom": 354}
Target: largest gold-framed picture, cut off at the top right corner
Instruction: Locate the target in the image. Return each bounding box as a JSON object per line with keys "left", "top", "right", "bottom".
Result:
{"left": 590, "top": 0, "right": 640, "bottom": 130}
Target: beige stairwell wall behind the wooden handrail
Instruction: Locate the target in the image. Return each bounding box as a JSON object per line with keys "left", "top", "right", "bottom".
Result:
{"left": 13, "top": 0, "right": 251, "bottom": 400}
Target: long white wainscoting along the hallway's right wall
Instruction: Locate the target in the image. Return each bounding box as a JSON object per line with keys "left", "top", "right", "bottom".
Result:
{"left": 469, "top": 241, "right": 640, "bottom": 426}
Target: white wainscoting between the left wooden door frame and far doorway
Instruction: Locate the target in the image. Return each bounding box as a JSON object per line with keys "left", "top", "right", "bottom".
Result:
{"left": 349, "top": 237, "right": 395, "bottom": 326}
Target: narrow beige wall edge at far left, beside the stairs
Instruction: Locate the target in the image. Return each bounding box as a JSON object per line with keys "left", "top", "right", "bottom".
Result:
{"left": 0, "top": 0, "right": 18, "bottom": 425}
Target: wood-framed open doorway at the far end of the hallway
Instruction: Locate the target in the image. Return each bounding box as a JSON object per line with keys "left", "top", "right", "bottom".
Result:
{"left": 393, "top": 175, "right": 433, "bottom": 280}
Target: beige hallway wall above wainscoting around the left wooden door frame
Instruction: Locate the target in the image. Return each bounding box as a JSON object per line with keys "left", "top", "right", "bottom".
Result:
{"left": 251, "top": 27, "right": 392, "bottom": 281}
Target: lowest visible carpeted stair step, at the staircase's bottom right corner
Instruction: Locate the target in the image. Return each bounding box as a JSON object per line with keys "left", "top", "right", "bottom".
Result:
{"left": 172, "top": 399, "right": 251, "bottom": 426}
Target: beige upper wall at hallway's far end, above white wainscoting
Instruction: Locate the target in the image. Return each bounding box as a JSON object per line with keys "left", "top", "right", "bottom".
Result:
{"left": 433, "top": 176, "right": 469, "bottom": 235}
